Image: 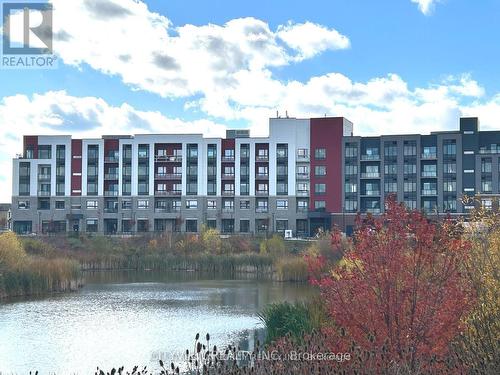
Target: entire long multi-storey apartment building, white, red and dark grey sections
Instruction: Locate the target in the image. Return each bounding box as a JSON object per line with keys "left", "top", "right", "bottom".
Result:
{"left": 12, "top": 117, "right": 500, "bottom": 236}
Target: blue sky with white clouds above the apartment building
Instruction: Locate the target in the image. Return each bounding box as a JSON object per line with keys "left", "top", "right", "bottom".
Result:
{"left": 0, "top": 0, "right": 500, "bottom": 201}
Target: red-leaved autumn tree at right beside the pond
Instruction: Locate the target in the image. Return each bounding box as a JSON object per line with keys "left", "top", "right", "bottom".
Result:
{"left": 312, "top": 199, "right": 473, "bottom": 373}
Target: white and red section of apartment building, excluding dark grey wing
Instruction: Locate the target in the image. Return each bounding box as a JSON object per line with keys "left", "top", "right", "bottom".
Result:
{"left": 8, "top": 118, "right": 352, "bottom": 236}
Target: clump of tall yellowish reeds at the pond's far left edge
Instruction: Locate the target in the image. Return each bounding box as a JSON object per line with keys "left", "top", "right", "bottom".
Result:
{"left": 0, "top": 233, "right": 82, "bottom": 298}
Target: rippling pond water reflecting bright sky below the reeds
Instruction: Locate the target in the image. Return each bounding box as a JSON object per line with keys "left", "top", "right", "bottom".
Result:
{"left": 0, "top": 271, "right": 314, "bottom": 374}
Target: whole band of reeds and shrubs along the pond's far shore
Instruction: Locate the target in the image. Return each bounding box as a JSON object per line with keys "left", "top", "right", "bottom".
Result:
{"left": 0, "top": 228, "right": 316, "bottom": 299}
